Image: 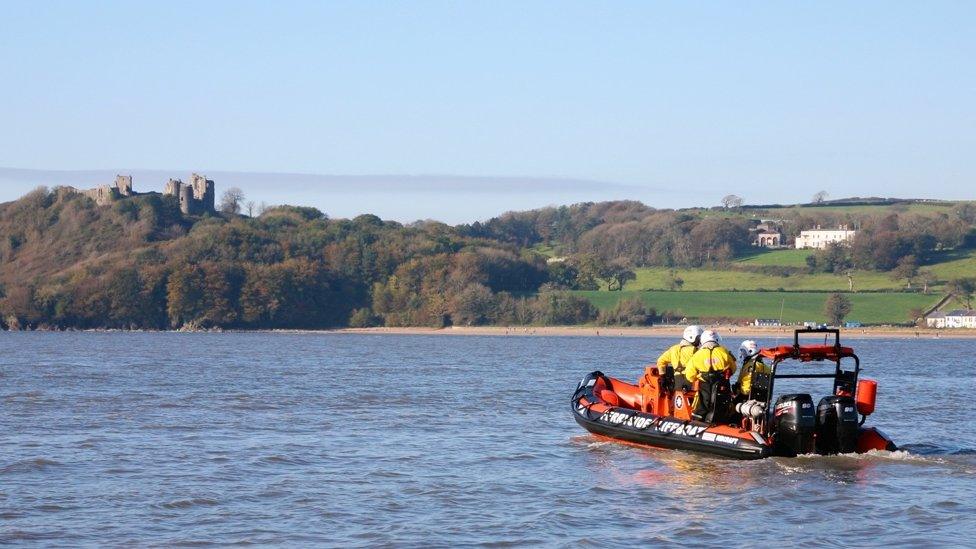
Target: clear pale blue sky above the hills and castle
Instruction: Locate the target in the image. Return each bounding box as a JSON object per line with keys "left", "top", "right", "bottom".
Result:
{"left": 0, "top": 0, "right": 976, "bottom": 222}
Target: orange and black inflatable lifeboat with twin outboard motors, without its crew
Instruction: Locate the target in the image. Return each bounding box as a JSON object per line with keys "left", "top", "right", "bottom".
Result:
{"left": 572, "top": 329, "right": 896, "bottom": 459}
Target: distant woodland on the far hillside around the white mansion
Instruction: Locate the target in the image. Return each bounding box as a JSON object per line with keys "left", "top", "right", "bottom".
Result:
{"left": 458, "top": 201, "right": 976, "bottom": 272}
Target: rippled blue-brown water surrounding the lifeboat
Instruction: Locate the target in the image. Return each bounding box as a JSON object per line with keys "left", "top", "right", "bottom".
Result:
{"left": 0, "top": 333, "right": 976, "bottom": 547}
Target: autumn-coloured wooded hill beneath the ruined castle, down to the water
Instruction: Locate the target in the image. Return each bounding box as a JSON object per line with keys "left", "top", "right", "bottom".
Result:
{"left": 0, "top": 189, "right": 653, "bottom": 329}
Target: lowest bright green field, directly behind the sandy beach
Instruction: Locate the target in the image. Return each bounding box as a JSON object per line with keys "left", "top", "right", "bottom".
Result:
{"left": 574, "top": 290, "right": 941, "bottom": 324}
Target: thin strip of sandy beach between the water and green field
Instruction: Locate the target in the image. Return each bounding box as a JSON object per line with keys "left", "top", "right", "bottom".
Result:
{"left": 330, "top": 326, "right": 976, "bottom": 339}
